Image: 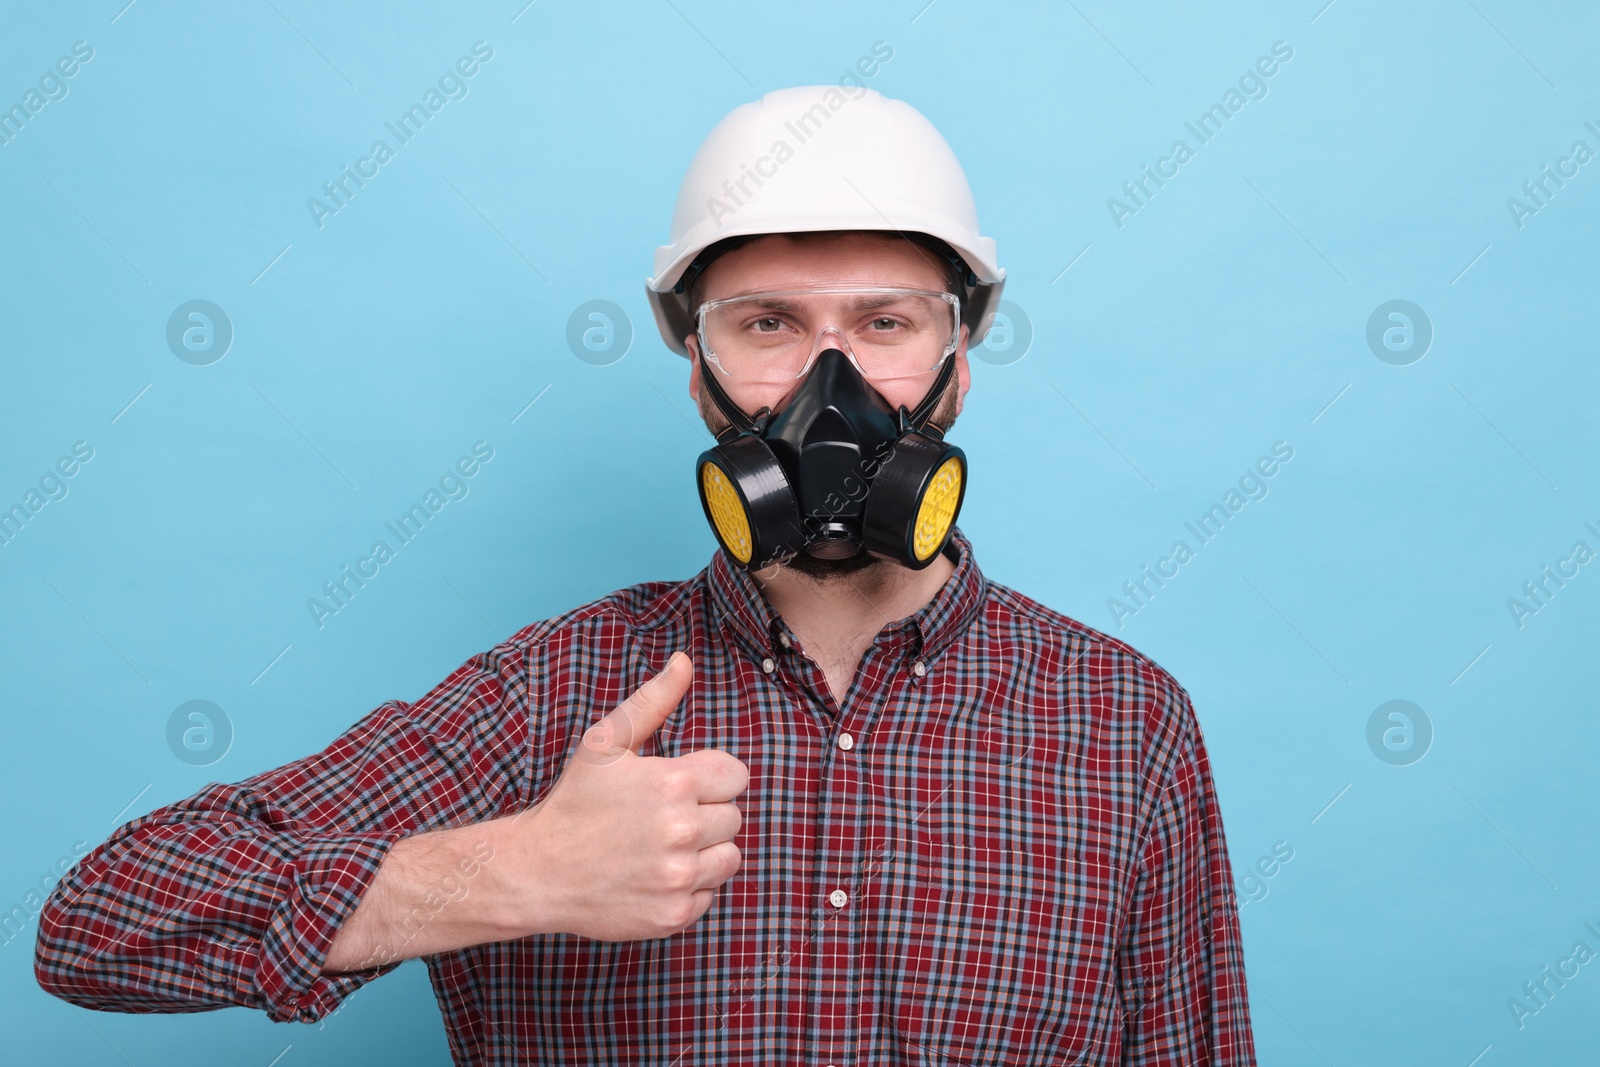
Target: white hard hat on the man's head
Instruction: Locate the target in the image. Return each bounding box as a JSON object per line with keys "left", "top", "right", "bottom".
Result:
{"left": 645, "top": 85, "right": 1005, "bottom": 355}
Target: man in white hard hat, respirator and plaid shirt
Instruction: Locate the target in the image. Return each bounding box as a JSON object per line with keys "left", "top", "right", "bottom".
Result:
{"left": 28, "top": 86, "right": 1254, "bottom": 1065}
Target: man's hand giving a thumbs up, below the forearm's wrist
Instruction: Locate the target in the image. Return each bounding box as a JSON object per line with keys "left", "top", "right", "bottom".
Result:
{"left": 496, "top": 653, "right": 750, "bottom": 941}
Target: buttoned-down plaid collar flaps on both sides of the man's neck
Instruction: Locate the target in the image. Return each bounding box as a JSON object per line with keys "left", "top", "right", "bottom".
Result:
{"left": 706, "top": 526, "right": 987, "bottom": 659}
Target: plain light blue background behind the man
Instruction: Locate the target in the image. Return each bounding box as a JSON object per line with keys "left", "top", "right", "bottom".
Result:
{"left": 0, "top": 0, "right": 1600, "bottom": 1067}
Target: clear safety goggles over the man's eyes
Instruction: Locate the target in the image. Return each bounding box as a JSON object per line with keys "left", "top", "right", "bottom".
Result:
{"left": 694, "top": 286, "right": 962, "bottom": 384}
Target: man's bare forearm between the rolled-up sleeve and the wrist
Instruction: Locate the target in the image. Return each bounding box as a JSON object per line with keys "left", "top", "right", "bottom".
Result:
{"left": 322, "top": 819, "right": 544, "bottom": 974}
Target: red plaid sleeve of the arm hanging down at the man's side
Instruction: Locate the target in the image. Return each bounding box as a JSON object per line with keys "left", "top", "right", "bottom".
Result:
{"left": 1118, "top": 689, "right": 1256, "bottom": 1067}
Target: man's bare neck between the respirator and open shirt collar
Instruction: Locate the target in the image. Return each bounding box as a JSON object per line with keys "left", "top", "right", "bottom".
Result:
{"left": 757, "top": 552, "right": 955, "bottom": 675}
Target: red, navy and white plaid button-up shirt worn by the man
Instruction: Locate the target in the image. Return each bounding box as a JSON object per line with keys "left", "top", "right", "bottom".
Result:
{"left": 35, "top": 531, "right": 1254, "bottom": 1067}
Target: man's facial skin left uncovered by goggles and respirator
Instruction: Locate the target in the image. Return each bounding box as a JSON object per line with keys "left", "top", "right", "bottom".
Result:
{"left": 685, "top": 234, "right": 970, "bottom": 579}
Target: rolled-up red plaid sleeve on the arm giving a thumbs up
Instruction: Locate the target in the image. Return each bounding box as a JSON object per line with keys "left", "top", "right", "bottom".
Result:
{"left": 34, "top": 643, "right": 530, "bottom": 1022}
